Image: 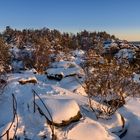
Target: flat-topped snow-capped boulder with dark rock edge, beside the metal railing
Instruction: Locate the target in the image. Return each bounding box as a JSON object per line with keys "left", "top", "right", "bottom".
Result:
{"left": 35, "top": 98, "right": 82, "bottom": 126}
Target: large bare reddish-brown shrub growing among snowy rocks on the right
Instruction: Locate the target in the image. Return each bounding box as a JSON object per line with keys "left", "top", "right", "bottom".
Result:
{"left": 84, "top": 51, "right": 139, "bottom": 116}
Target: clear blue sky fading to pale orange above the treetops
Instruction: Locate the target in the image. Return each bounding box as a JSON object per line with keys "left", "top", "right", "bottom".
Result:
{"left": 0, "top": 0, "right": 140, "bottom": 41}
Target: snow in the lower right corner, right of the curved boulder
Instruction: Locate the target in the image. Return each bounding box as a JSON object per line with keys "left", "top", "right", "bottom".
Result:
{"left": 119, "top": 97, "right": 140, "bottom": 140}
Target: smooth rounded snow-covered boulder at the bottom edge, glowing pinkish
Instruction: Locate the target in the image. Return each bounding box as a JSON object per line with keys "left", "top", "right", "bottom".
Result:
{"left": 68, "top": 119, "right": 119, "bottom": 140}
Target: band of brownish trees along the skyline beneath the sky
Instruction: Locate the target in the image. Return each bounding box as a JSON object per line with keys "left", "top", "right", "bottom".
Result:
{"left": 0, "top": 26, "right": 117, "bottom": 50}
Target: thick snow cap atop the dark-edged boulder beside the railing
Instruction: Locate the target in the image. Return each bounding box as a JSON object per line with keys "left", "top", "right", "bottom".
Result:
{"left": 33, "top": 98, "right": 80, "bottom": 124}
